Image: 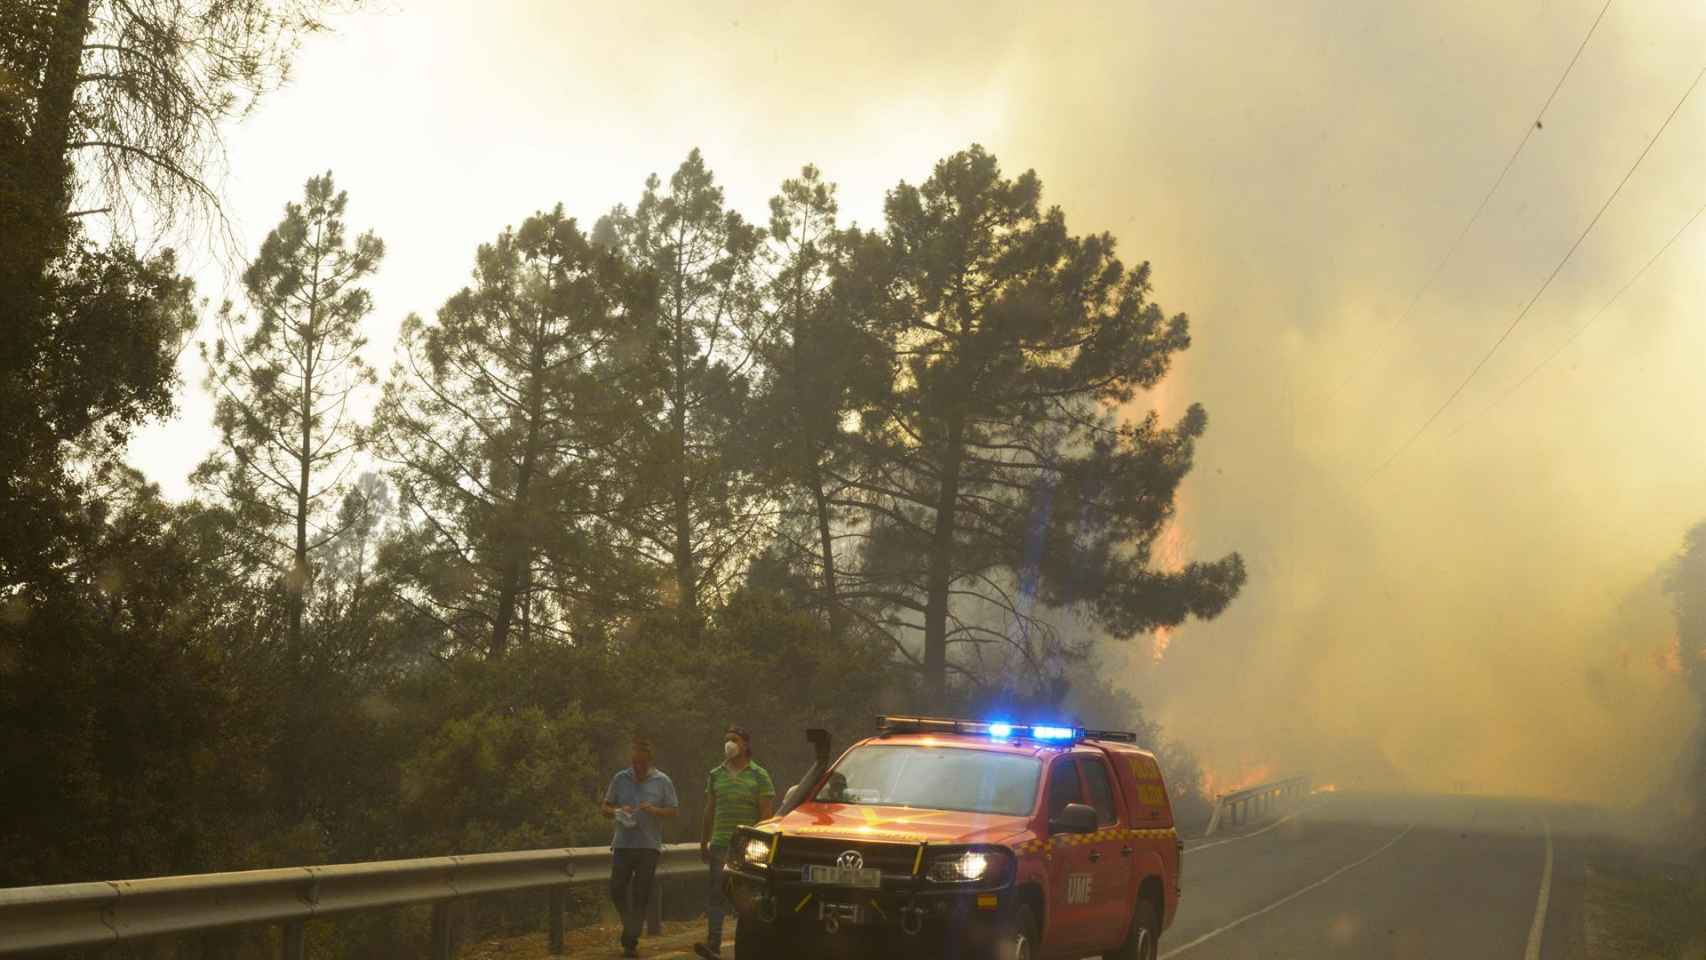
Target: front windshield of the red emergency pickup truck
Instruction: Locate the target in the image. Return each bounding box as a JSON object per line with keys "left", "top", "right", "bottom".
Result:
{"left": 812, "top": 745, "right": 1042, "bottom": 817}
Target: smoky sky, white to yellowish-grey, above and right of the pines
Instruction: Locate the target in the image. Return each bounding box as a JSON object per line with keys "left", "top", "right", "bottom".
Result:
{"left": 135, "top": 0, "right": 1706, "bottom": 798}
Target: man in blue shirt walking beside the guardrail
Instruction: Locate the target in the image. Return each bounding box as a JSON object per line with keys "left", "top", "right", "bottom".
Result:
{"left": 602, "top": 737, "right": 681, "bottom": 957}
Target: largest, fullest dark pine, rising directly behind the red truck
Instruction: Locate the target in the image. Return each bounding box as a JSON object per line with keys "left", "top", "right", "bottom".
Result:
{"left": 838, "top": 147, "right": 1244, "bottom": 703}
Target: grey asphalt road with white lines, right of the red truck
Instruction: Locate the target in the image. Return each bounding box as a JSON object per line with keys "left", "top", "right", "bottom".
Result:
{"left": 1160, "top": 793, "right": 1593, "bottom": 960}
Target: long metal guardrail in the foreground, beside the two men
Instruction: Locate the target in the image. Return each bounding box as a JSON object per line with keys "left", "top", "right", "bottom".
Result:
{"left": 0, "top": 844, "right": 705, "bottom": 960}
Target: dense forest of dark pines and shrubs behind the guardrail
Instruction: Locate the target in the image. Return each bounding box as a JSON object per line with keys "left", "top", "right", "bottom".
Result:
{"left": 0, "top": 0, "right": 1244, "bottom": 948}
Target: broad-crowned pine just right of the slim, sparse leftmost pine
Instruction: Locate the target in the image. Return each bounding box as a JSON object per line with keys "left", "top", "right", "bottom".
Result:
{"left": 377, "top": 206, "right": 657, "bottom": 655}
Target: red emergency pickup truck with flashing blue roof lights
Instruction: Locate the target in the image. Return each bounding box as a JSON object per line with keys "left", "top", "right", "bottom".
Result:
{"left": 727, "top": 716, "right": 1184, "bottom": 960}
